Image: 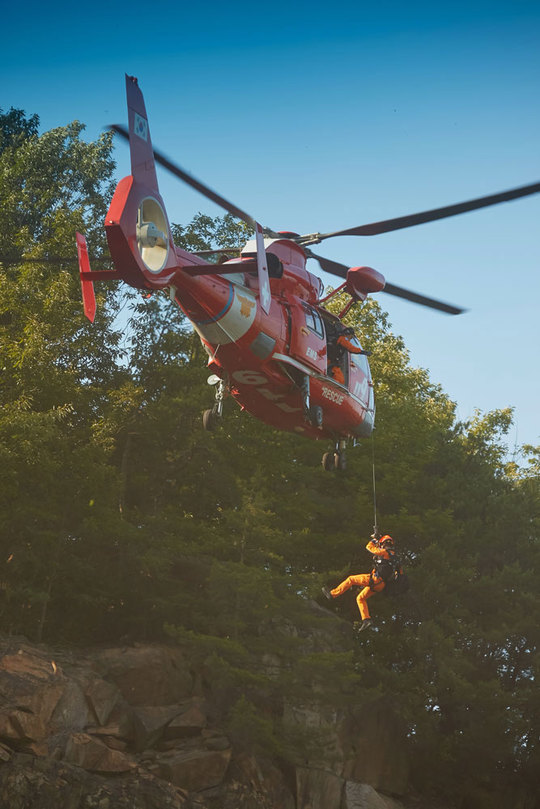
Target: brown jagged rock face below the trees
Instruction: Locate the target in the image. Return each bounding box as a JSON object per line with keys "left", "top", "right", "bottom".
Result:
{"left": 0, "top": 637, "right": 407, "bottom": 809}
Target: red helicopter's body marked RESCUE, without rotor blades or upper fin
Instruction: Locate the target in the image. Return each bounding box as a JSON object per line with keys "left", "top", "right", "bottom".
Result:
{"left": 105, "top": 176, "right": 375, "bottom": 440}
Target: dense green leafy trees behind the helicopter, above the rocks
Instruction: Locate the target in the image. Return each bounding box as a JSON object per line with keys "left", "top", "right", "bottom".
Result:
{"left": 0, "top": 110, "right": 540, "bottom": 800}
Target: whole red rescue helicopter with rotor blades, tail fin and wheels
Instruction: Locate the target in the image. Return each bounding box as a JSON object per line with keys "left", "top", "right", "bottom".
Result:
{"left": 77, "top": 76, "right": 540, "bottom": 470}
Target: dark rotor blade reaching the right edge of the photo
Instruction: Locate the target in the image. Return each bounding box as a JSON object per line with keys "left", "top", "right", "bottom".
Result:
{"left": 317, "top": 183, "right": 540, "bottom": 241}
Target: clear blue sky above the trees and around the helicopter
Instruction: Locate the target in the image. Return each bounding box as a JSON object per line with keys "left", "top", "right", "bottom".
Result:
{"left": 0, "top": 0, "right": 540, "bottom": 452}
